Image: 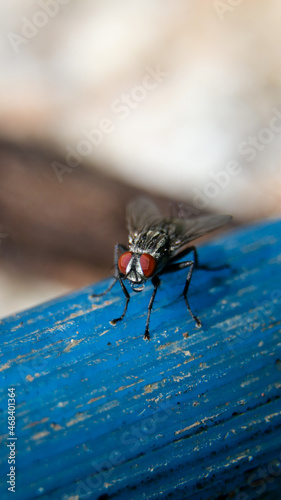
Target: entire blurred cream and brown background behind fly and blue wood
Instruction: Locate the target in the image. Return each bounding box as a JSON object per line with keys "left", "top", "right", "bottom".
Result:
{"left": 0, "top": 0, "right": 281, "bottom": 317}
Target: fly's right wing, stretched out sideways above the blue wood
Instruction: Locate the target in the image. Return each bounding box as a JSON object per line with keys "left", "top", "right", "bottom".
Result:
{"left": 167, "top": 215, "right": 232, "bottom": 255}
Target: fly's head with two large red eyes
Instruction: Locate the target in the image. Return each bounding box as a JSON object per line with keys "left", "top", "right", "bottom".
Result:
{"left": 118, "top": 251, "right": 156, "bottom": 292}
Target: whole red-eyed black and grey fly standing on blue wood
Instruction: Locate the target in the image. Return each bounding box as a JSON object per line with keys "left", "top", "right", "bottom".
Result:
{"left": 92, "top": 198, "right": 232, "bottom": 339}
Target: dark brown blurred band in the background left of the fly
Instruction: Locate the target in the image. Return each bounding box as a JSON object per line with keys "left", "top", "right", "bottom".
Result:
{"left": 0, "top": 142, "right": 236, "bottom": 286}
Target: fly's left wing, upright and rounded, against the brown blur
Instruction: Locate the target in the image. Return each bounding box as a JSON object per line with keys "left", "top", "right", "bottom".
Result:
{"left": 126, "top": 198, "right": 163, "bottom": 238}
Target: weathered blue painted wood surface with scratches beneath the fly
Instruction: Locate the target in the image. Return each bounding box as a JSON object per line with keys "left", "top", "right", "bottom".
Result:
{"left": 0, "top": 221, "right": 281, "bottom": 500}
